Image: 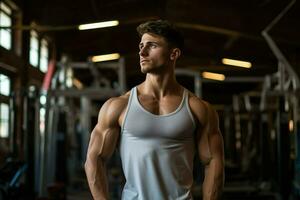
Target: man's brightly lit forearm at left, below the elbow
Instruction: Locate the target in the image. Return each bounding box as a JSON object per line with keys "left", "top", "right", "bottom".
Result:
{"left": 85, "top": 159, "right": 108, "bottom": 200}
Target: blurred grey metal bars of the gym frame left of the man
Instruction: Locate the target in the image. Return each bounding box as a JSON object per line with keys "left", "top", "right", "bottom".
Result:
{"left": 36, "top": 56, "right": 127, "bottom": 195}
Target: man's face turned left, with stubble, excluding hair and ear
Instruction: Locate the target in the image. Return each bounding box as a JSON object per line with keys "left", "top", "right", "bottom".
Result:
{"left": 139, "top": 33, "right": 171, "bottom": 73}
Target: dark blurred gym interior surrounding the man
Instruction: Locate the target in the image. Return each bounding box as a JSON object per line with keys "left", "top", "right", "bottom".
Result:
{"left": 0, "top": 0, "right": 300, "bottom": 200}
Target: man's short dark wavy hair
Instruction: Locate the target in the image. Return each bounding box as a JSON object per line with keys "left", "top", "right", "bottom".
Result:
{"left": 136, "top": 20, "right": 184, "bottom": 51}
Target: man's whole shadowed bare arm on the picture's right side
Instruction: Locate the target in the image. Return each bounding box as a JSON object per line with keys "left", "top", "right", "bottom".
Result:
{"left": 197, "top": 103, "right": 224, "bottom": 200}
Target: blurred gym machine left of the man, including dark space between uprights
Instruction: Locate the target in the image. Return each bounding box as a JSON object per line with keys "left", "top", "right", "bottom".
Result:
{"left": 32, "top": 56, "right": 126, "bottom": 196}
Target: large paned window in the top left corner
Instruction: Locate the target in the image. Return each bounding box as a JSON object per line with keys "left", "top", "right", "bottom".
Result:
{"left": 0, "top": 2, "right": 12, "bottom": 50}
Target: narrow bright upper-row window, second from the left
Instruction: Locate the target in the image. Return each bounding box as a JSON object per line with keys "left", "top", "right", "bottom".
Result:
{"left": 29, "top": 31, "right": 39, "bottom": 67}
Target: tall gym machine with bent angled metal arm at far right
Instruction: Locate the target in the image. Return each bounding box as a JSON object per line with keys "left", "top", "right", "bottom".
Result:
{"left": 261, "top": 0, "right": 300, "bottom": 199}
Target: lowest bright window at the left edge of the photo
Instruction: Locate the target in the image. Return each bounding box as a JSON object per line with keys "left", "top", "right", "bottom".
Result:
{"left": 0, "top": 103, "right": 9, "bottom": 138}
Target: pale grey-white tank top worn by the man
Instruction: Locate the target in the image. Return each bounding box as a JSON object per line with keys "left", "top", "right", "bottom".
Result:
{"left": 120, "top": 87, "right": 196, "bottom": 200}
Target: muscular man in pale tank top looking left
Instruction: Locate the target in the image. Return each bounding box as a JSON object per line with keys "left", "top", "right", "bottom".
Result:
{"left": 85, "top": 20, "right": 224, "bottom": 200}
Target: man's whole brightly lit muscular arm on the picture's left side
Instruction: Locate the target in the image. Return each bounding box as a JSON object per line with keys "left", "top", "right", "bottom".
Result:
{"left": 85, "top": 99, "right": 120, "bottom": 200}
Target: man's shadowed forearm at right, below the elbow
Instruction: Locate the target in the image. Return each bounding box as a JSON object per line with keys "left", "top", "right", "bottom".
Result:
{"left": 203, "top": 159, "right": 224, "bottom": 200}
